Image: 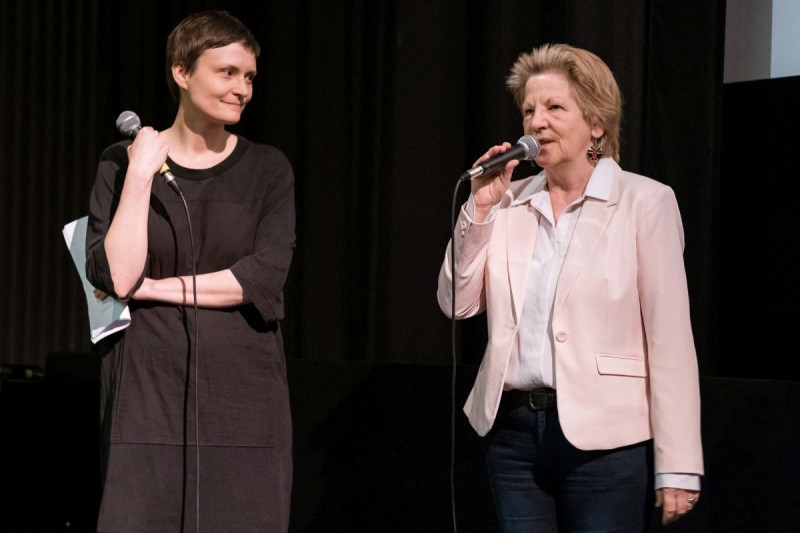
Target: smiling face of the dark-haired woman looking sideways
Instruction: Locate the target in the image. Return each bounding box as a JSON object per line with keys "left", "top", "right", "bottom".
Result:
{"left": 172, "top": 42, "right": 256, "bottom": 125}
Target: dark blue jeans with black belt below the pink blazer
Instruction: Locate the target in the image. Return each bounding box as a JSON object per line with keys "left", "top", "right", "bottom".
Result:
{"left": 486, "top": 406, "right": 653, "bottom": 533}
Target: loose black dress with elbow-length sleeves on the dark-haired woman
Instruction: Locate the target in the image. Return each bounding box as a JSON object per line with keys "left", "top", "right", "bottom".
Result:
{"left": 86, "top": 137, "right": 295, "bottom": 533}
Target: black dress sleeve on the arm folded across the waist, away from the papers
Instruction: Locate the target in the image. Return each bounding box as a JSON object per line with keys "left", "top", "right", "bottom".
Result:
{"left": 231, "top": 153, "right": 295, "bottom": 321}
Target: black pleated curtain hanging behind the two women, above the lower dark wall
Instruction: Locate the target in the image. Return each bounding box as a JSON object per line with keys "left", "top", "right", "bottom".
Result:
{"left": 0, "top": 0, "right": 725, "bottom": 374}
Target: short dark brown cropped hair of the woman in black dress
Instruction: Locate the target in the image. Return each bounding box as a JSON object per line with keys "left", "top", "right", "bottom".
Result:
{"left": 167, "top": 11, "right": 261, "bottom": 102}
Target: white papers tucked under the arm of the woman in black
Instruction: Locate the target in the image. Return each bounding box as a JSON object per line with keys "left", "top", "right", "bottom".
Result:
{"left": 62, "top": 217, "right": 131, "bottom": 343}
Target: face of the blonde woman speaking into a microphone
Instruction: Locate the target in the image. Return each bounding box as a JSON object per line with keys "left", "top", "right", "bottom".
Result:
{"left": 521, "top": 71, "right": 603, "bottom": 172}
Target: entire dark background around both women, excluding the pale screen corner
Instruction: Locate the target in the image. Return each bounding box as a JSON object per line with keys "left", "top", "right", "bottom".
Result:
{"left": 0, "top": 0, "right": 800, "bottom": 531}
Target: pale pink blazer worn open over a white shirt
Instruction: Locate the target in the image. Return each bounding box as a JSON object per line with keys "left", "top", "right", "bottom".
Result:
{"left": 438, "top": 159, "right": 703, "bottom": 475}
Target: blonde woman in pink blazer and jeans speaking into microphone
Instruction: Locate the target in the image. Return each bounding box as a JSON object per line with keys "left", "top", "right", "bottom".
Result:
{"left": 438, "top": 44, "right": 703, "bottom": 533}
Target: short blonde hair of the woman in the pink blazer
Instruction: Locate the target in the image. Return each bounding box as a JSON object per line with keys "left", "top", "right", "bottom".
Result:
{"left": 506, "top": 44, "right": 622, "bottom": 161}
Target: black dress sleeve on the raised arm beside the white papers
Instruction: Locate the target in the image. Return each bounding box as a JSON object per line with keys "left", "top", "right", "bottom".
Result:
{"left": 86, "top": 141, "right": 144, "bottom": 300}
